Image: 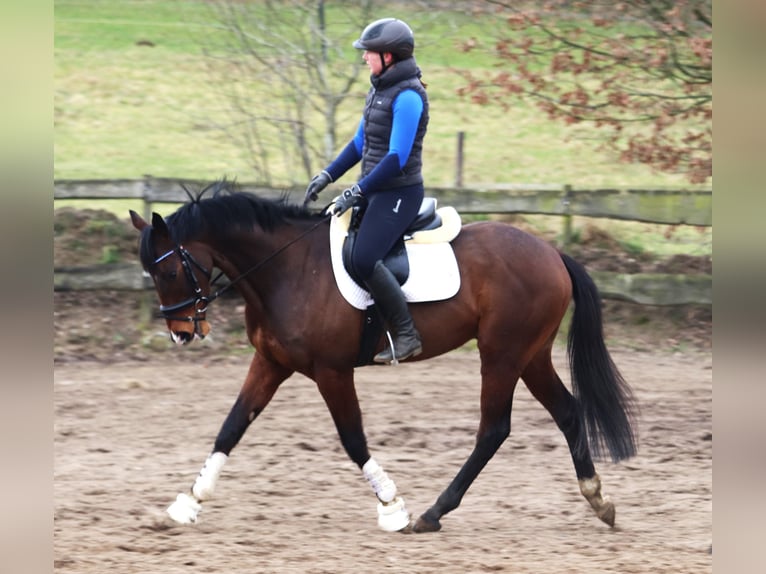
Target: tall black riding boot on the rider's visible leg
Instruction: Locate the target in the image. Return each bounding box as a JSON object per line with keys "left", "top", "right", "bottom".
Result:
{"left": 366, "top": 261, "right": 423, "bottom": 363}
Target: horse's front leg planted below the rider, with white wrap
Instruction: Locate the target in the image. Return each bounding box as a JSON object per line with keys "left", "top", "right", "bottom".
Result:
{"left": 315, "top": 370, "right": 410, "bottom": 532}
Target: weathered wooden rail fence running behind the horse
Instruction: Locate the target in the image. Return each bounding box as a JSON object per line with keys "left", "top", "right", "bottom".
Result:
{"left": 54, "top": 176, "right": 713, "bottom": 305}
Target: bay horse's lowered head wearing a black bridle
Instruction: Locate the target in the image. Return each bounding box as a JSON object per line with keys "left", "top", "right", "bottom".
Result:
{"left": 130, "top": 210, "right": 213, "bottom": 344}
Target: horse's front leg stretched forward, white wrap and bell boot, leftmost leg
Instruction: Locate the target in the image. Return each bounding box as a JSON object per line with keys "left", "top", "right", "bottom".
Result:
{"left": 167, "top": 353, "right": 293, "bottom": 524}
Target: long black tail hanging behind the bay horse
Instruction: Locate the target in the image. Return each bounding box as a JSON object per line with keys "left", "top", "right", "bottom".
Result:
{"left": 561, "top": 253, "right": 636, "bottom": 461}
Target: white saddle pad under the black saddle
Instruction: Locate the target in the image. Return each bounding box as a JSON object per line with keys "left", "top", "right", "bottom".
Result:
{"left": 330, "top": 208, "right": 460, "bottom": 309}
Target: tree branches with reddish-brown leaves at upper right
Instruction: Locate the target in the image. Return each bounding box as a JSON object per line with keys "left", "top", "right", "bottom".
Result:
{"left": 460, "top": 0, "right": 713, "bottom": 183}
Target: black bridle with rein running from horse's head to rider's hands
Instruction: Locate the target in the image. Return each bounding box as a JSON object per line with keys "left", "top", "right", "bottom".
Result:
{"left": 152, "top": 214, "right": 332, "bottom": 332}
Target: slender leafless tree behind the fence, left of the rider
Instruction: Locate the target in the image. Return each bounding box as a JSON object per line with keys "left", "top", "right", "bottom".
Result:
{"left": 201, "top": 0, "right": 373, "bottom": 183}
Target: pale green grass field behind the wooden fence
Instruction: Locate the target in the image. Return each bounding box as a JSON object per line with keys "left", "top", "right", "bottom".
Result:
{"left": 54, "top": 0, "right": 712, "bottom": 256}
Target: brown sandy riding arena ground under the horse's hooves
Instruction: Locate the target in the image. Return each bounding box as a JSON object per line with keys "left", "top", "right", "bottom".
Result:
{"left": 54, "top": 350, "right": 713, "bottom": 574}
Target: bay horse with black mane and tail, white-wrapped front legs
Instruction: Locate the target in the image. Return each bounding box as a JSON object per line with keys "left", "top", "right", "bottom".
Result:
{"left": 130, "top": 180, "right": 637, "bottom": 533}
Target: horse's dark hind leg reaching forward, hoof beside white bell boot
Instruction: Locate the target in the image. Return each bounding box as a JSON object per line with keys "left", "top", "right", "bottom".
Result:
{"left": 412, "top": 349, "right": 518, "bottom": 532}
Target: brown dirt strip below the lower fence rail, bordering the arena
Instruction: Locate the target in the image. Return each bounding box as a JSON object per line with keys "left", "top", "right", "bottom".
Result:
{"left": 53, "top": 291, "right": 713, "bottom": 365}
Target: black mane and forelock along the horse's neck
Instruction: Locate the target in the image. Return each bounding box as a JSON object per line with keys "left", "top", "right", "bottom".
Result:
{"left": 140, "top": 180, "right": 322, "bottom": 268}
